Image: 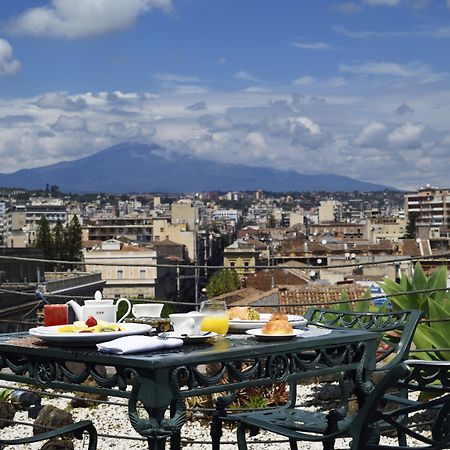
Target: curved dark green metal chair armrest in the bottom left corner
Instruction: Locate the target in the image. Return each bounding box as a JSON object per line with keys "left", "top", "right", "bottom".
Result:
{"left": 0, "top": 420, "right": 97, "bottom": 450}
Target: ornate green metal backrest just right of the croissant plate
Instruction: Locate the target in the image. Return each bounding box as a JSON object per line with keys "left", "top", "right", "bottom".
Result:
{"left": 305, "top": 308, "right": 423, "bottom": 370}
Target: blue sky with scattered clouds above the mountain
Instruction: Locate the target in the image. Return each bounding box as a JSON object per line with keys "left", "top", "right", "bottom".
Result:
{"left": 0, "top": 0, "right": 450, "bottom": 190}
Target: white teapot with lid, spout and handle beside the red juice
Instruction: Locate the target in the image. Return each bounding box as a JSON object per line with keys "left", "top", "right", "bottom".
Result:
{"left": 67, "top": 291, "right": 131, "bottom": 323}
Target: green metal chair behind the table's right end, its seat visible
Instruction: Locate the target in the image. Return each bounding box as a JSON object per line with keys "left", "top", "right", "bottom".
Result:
{"left": 211, "top": 308, "right": 423, "bottom": 450}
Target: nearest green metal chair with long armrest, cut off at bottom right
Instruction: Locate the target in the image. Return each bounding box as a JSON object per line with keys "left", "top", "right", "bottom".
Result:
{"left": 237, "top": 360, "right": 450, "bottom": 450}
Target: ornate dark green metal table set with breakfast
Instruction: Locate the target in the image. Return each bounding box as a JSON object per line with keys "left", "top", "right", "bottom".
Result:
{"left": 0, "top": 330, "right": 378, "bottom": 450}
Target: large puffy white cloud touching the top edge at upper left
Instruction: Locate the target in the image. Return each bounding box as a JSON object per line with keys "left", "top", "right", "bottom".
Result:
{"left": 6, "top": 0, "right": 171, "bottom": 39}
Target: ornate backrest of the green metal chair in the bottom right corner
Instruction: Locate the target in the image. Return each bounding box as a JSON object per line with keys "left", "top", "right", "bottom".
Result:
{"left": 350, "top": 360, "right": 450, "bottom": 450}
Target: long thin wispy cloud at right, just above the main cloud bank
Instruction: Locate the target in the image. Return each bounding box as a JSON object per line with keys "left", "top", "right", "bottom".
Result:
{"left": 339, "top": 61, "right": 447, "bottom": 83}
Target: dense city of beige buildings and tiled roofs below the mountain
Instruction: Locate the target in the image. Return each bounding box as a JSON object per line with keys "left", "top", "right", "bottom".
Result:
{"left": 0, "top": 181, "right": 444, "bottom": 303}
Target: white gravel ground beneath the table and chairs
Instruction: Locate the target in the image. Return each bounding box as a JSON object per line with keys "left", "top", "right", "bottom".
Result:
{"left": 1, "top": 385, "right": 414, "bottom": 450}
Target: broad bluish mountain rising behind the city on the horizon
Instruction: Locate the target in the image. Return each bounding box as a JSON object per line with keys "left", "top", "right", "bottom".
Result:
{"left": 0, "top": 143, "right": 393, "bottom": 193}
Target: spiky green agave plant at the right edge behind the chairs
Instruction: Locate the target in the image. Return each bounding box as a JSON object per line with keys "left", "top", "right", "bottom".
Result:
{"left": 379, "top": 263, "right": 450, "bottom": 360}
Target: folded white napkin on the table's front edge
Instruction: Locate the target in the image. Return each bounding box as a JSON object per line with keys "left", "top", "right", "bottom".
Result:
{"left": 97, "top": 335, "right": 183, "bottom": 355}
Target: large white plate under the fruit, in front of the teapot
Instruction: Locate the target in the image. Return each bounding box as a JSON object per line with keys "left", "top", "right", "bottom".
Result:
{"left": 28, "top": 323, "right": 152, "bottom": 345}
